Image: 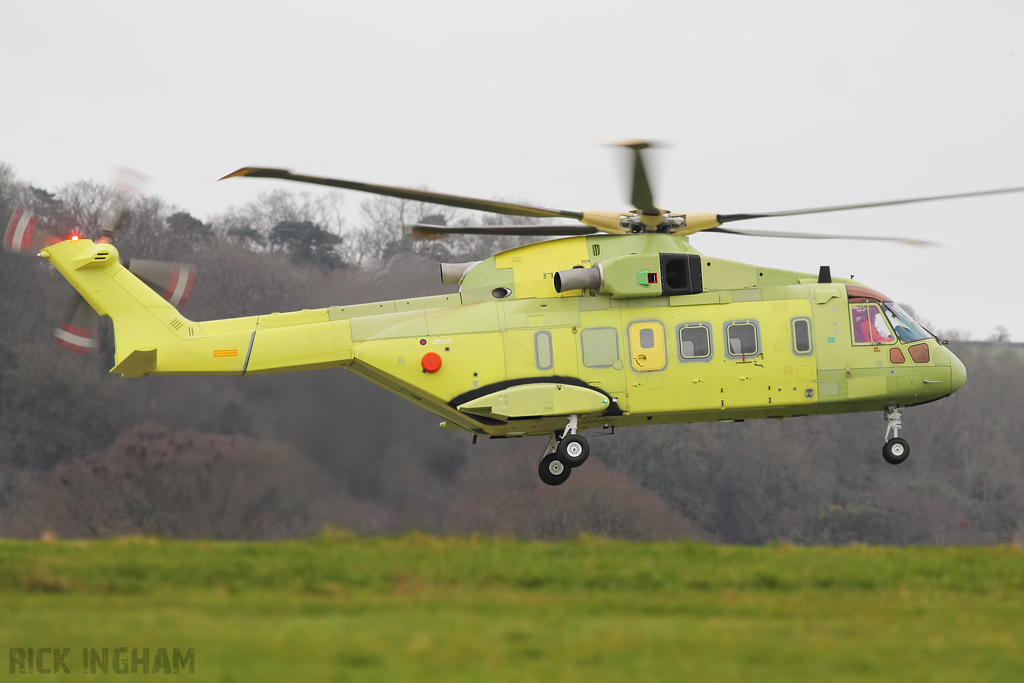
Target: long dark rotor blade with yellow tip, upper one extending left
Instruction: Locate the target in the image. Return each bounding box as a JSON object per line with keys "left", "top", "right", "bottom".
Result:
{"left": 221, "top": 167, "right": 583, "bottom": 219}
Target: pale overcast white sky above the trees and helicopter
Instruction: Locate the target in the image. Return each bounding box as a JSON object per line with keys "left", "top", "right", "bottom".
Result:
{"left": 0, "top": 0, "right": 1024, "bottom": 341}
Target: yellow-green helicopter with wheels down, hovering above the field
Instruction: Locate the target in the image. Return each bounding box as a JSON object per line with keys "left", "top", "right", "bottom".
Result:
{"left": 40, "top": 140, "right": 1024, "bottom": 485}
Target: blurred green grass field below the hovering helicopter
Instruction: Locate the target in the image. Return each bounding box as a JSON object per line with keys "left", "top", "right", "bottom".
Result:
{"left": 0, "top": 533, "right": 1024, "bottom": 682}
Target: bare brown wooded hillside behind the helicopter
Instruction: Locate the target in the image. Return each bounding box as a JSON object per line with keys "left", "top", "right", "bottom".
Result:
{"left": 0, "top": 165, "right": 1024, "bottom": 545}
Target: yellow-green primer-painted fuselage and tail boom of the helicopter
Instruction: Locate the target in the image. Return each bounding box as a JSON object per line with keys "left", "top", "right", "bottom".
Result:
{"left": 41, "top": 236, "right": 965, "bottom": 436}
